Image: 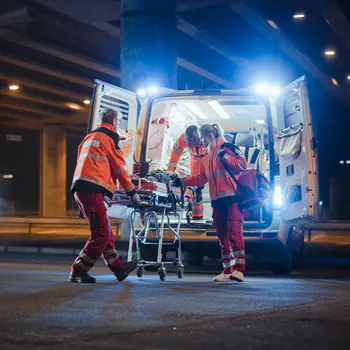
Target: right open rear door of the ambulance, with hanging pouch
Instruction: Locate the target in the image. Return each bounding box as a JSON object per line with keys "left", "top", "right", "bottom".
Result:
{"left": 275, "top": 76, "right": 318, "bottom": 224}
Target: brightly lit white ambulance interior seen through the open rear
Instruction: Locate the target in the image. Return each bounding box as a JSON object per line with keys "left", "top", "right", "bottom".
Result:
{"left": 146, "top": 96, "right": 274, "bottom": 225}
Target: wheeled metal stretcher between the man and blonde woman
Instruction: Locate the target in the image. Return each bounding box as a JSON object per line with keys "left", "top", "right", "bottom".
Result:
{"left": 113, "top": 183, "right": 186, "bottom": 281}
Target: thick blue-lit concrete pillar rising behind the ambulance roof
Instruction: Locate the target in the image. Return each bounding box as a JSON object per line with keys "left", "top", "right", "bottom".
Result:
{"left": 121, "top": 0, "right": 177, "bottom": 91}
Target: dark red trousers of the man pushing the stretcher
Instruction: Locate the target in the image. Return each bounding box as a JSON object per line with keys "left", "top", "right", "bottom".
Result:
{"left": 72, "top": 192, "right": 123, "bottom": 271}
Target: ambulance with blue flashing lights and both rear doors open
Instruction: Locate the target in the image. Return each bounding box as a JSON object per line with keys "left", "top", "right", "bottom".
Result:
{"left": 88, "top": 76, "right": 319, "bottom": 274}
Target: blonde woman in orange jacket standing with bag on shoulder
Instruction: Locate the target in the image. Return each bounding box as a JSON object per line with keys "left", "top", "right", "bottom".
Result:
{"left": 181, "top": 124, "right": 247, "bottom": 282}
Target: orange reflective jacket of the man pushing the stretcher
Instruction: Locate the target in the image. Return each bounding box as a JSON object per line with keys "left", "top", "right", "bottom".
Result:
{"left": 72, "top": 123, "right": 134, "bottom": 195}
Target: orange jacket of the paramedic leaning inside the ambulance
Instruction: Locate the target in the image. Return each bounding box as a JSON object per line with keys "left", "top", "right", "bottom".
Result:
{"left": 168, "top": 134, "right": 208, "bottom": 176}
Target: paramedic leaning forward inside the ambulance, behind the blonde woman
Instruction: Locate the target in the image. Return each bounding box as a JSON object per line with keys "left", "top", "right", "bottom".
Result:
{"left": 168, "top": 125, "right": 208, "bottom": 220}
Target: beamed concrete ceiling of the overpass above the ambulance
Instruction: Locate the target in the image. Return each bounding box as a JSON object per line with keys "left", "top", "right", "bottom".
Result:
{"left": 0, "top": 0, "right": 350, "bottom": 135}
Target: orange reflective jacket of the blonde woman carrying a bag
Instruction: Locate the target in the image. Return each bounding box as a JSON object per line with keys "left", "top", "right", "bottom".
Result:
{"left": 184, "top": 139, "right": 247, "bottom": 207}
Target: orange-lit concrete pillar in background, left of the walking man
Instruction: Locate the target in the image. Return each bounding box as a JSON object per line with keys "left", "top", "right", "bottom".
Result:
{"left": 40, "top": 125, "right": 67, "bottom": 217}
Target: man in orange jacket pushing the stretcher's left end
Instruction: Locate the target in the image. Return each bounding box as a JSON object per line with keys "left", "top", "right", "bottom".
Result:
{"left": 69, "top": 109, "right": 140, "bottom": 283}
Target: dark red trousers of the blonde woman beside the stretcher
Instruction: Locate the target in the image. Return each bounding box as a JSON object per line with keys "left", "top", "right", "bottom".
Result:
{"left": 213, "top": 203, "right": 245, "bottom": 273}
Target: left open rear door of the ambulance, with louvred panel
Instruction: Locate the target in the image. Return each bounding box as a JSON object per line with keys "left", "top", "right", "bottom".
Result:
{"left": 87, "top": 80, "right": 138, "bottom": 174}
